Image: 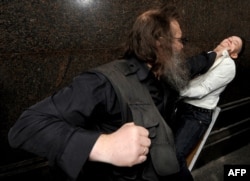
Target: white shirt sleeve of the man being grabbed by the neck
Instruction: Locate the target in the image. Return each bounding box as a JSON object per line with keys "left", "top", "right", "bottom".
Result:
{"left": 180, "top": 58, "right": 236, "bottom": 99}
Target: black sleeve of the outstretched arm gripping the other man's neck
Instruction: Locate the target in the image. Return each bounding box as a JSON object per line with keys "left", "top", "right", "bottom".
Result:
{"left": 187, "top": 52, "right": 216, "bottom": 79}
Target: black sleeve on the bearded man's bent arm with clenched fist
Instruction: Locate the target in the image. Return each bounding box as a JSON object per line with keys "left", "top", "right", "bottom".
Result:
{"left": 8, "top": 72, "right": 112, "bottom": 179}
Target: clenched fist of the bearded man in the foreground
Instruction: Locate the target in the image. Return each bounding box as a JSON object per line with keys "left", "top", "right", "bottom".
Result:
{"left": 89, "top": 123, "right": 151, "bottom": 167}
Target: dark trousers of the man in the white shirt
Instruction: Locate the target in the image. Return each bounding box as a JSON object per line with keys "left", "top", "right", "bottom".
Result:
{"left": 173, "top": 103, "right": 213, "bottom": 181}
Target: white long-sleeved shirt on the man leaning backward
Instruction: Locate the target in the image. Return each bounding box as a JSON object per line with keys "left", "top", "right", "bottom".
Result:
{"left": 180, "top": 50, "right": 236, "bottom": 109}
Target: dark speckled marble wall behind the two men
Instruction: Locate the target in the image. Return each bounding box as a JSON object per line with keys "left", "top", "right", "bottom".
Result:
{"left": 0, "top": 0, "right": 250, "bottom": 166}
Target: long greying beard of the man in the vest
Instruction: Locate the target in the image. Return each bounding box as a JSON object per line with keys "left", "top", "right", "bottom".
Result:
{"left": 161, "top": 53, "right": 190, "bottom": 91}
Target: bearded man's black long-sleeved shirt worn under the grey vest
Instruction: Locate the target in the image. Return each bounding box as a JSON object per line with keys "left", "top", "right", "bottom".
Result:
{"left": 8, "top": 52, "right": 214, "bottom": 180}
